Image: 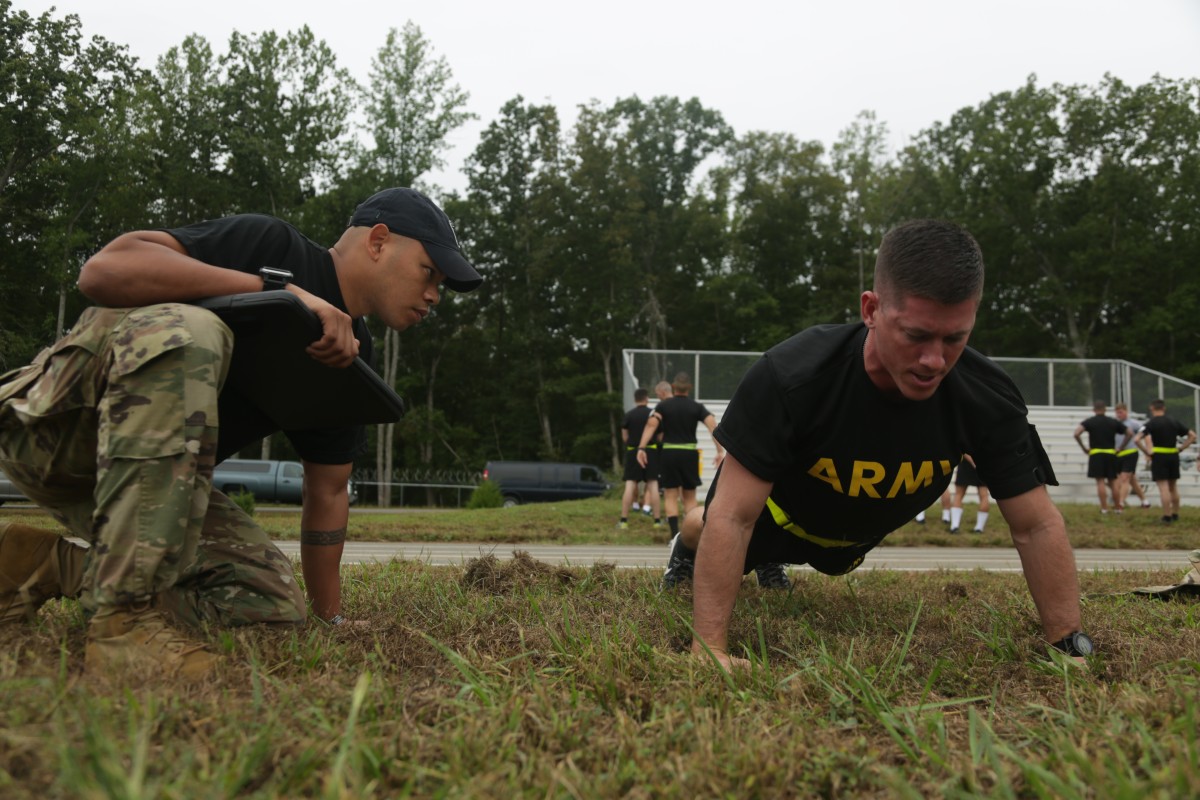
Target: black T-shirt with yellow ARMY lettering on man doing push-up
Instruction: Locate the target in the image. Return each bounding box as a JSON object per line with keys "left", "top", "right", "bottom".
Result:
{"left": 715, "top": 324, "right": 1056, "bottom": 542}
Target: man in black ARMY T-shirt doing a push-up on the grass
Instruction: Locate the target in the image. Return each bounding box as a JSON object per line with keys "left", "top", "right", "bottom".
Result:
{"left": 667, "top": 219, "right": 1092, "bottom": 667}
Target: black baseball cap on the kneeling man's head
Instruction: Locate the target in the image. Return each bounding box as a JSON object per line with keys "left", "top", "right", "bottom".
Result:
{"left": 350, "top": 188, "right": 484, "bottom": 291}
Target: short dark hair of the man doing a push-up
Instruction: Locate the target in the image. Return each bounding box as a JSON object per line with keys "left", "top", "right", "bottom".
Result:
{"left": 875, "top": 219, "right": 983, "bottom": 306}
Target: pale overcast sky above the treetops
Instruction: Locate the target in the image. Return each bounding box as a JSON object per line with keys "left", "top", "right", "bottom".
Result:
{"left": 14, "top": 0, "right": 1200, "bottom": 190}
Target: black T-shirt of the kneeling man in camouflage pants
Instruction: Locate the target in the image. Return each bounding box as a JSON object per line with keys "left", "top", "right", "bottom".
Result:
{"left": 166, "top": 213, "right": 373, "bottom": 464}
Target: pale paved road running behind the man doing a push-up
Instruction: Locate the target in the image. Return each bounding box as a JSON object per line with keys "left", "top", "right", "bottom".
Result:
{"left": 276, "top": 541, "right": 1188, "bottom": 573}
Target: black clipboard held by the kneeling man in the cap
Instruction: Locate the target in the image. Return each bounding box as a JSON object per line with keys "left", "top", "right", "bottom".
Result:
{"left": 193, "top": 290, "right": 404, "bottom": 431}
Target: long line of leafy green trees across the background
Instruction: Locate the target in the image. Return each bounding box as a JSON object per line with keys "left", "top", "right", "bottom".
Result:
{"left": 0, "top": 0, "right": 1200, "bottom": 494}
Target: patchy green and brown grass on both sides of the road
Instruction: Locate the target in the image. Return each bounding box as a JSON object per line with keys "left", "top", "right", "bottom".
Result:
{"left": 0, "top": 503, "right": 1200, "bottom": 800}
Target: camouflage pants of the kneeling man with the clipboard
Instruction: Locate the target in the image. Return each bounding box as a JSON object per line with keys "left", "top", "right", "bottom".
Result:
{"left": 0, "top": 303, "right": 305, "bottom": 625}
